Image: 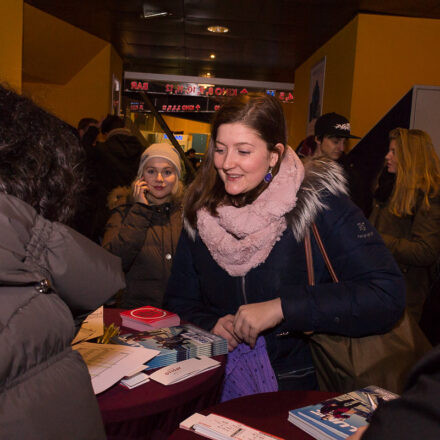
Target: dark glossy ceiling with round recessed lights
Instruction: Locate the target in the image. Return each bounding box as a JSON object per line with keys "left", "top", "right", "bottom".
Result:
{"left": 25, "top": 0, "right": 440, "bottom": 83}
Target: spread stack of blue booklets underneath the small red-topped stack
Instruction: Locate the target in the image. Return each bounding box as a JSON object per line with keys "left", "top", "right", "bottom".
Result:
{"left": 113, "top": 324, "right": 228, "bottom": 369}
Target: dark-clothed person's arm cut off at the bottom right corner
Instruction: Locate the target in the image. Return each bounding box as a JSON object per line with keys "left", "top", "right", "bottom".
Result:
{"left": 347, "top": 345, "right": 440, "bottom": 440}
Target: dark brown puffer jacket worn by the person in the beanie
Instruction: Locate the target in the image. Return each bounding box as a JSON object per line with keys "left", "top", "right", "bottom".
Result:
{"left": 102, "top": 187, "right": 182, "bottom": 308}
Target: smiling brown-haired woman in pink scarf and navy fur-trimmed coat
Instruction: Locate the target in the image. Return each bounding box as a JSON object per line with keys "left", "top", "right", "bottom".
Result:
{"left": 166, "top": 96, "right": 405, "bottom": 400}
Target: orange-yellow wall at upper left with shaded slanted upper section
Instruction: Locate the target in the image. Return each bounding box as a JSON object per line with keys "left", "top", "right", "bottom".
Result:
{"left": 23, "top": 4, "right": 122, "bottom": 126}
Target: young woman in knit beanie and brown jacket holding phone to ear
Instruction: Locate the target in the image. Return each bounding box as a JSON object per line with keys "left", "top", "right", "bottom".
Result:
{"left": 102, "top": 144, "right": 183, "bottom": 309}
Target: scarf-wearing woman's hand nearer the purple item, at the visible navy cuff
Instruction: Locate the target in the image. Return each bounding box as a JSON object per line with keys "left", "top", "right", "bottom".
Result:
{"left": 234, "top": 298, "right": 284, "bottom": 348}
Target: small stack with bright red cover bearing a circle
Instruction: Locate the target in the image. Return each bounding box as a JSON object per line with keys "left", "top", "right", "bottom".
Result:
{"left": 120, "top": 306, "right": 180, "bottom": 331}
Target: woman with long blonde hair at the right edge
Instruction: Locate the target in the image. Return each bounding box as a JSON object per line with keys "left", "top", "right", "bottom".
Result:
{"left": 370, "top": 128, "right": 440, "bottom": 321}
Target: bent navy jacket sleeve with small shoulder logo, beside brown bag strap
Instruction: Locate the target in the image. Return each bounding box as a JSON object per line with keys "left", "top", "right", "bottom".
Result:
{"left": 279, "top": 196, "right": 405, "bottom": 336}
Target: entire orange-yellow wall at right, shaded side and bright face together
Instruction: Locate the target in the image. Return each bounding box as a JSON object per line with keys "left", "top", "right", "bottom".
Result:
{"left": 288, "top": 14, "right": 440, "bottom": 147}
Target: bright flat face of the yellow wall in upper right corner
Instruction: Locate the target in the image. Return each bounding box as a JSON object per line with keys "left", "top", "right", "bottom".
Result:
{"left": 350, "top": 14, "right": 440, "bottom": 136}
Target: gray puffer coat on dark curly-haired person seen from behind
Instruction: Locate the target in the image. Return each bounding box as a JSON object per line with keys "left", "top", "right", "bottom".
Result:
{"left": 0, "top": 194, "right": 124, "bottom": 440}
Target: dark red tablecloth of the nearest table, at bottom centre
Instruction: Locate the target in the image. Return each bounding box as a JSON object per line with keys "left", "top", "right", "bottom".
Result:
{"left": 169, "top": 391, "right": 338, "bottom": 440}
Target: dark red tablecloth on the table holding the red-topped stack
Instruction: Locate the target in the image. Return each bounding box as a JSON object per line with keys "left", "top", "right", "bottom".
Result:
{"left": 97, "top": 309, "right": 226, "bottom": 440}
